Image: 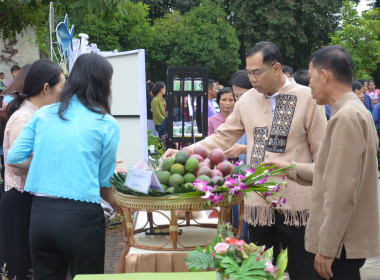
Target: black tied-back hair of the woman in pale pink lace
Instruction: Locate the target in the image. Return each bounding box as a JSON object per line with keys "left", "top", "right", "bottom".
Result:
{"left": 6, "top": 59, "right": 62, "bottom": 118}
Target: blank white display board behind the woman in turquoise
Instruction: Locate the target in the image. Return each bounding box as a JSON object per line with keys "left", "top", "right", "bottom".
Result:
{"left": 101, "top": 49, "right": 148, "bottom": 167}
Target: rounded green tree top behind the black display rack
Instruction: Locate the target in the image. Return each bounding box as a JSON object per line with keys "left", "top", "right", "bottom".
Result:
{"left": 148, "top": 0, "right": 240, "bottom": 82}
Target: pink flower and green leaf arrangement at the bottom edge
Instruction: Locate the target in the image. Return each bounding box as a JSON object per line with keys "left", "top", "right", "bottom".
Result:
{"left": 185, "top": 225, "right": 288, "bottom": 280}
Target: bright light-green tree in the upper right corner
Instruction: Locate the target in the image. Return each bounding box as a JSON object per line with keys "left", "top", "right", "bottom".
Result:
{"left": 330, "top": 1, "right": 380, "bottom": 79}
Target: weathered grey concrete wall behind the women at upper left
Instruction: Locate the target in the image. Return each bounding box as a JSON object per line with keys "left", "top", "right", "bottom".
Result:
{"left": 0, "top": 28, "right": 40, "bottom": 80}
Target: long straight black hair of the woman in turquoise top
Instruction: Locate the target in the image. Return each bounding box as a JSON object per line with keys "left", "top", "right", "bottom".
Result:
{"left": 58, "top": 53, "right": 113, "bottom": 120}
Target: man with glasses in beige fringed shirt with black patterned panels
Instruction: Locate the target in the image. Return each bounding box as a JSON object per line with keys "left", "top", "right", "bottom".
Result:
{"left": 166, "top": 42, "right": 327, "bottom": 280}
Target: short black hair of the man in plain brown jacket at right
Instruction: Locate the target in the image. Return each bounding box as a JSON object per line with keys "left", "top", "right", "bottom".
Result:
{"left": 310, "top": 45, "right": 354, "bottom": 86}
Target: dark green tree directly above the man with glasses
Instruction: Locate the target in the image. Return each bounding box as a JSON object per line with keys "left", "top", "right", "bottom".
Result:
{"left": 227, "top": 0, "right": 360, "bottom": 69}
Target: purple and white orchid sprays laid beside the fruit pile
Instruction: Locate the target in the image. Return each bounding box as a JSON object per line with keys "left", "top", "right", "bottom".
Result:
{"left": 180, "top": 162, "right": 294, "bottom": 208}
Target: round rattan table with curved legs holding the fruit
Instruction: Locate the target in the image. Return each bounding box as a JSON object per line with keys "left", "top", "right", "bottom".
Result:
{"left": 116, "top": 192, "right": 244, "bottom": 252}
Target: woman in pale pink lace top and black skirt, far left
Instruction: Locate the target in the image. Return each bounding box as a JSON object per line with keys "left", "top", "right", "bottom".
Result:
{"left": 0, "top": 60, "right": 65, "bottom": 280}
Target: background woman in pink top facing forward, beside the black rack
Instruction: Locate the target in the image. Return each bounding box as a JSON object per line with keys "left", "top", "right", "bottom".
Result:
{"left": 208, "top": 87, "right": 236, "bottom": 135}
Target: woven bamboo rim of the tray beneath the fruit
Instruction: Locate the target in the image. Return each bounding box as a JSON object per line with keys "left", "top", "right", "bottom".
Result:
{"left": 116, "top": 191, "right": 244, "bottom": 210}
